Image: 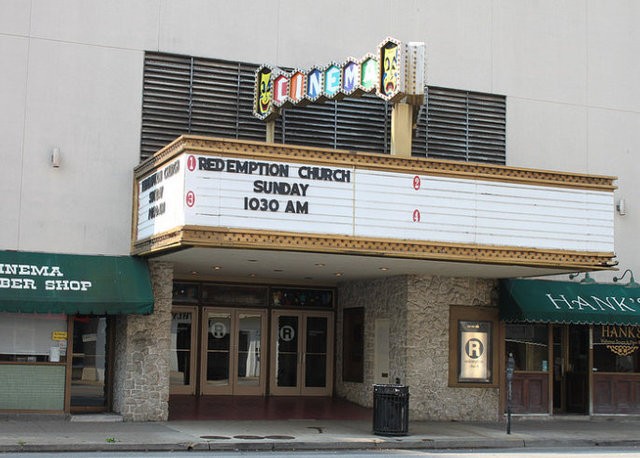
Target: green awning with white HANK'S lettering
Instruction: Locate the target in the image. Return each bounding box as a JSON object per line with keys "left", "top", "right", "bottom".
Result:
{"left": 500, "top": 280, "right": 640, "bottom": 325}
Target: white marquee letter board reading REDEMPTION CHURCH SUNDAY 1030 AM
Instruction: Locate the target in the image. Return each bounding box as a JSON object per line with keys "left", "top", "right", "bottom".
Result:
{"left": 136, "top": 153, "right": 613, "bottom": 256}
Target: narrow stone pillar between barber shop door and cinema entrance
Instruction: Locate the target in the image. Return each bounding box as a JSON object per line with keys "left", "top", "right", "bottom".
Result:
{"left": 113, "top": 262, "right": 173, "bottom": 421}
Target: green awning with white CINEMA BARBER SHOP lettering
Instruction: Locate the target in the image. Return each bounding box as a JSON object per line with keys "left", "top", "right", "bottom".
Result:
{"left": 0, "top": 251, "right": 153, "bottom": 315}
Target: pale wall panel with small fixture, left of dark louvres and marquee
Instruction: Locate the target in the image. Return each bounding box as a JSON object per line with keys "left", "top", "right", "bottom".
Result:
{"left": 18, "top": 39, "right": 142, "bottom": 254}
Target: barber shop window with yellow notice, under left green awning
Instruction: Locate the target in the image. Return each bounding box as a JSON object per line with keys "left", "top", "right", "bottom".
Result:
{"left": 0, "top": 313, "right": 67, "bottom": 363}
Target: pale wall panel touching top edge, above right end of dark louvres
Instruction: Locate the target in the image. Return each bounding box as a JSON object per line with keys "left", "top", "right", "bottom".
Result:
{"left": 492, "top": 0, "right": 588, "bottom": 104}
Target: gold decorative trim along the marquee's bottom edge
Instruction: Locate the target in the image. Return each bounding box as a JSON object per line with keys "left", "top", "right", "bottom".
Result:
{"left": 132, "top": 226, "right": 615, "bottom": 270}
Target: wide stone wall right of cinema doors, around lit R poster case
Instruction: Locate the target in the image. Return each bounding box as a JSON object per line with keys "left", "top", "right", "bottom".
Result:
{"left": 336, "top": 276, "right": 500, "bottom": 421}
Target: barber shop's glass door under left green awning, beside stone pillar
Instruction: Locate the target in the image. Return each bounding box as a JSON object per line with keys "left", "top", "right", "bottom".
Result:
{"left": 70, "top": 315, "right": 113, "bottom": 413}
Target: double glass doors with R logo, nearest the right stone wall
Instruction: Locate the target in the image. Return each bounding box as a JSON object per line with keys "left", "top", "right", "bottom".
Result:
{"left": 270, "top": 311, "right": 333, "bottom": 396}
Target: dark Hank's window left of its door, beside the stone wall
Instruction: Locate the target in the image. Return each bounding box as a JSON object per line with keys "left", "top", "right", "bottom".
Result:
{"left": 505, "top": 324, "right": 549, "bottom": 372}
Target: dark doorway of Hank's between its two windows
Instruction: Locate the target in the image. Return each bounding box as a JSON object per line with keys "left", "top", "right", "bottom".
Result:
{"left": 553, "top": 325, "right": 589, "bottom": 414}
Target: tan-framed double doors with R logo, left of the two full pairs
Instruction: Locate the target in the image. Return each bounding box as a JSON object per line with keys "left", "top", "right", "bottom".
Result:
{"left": 200, "top": 307, "right": 266, "bottom": 395}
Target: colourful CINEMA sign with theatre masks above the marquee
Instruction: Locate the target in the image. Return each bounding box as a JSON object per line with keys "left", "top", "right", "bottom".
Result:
{"left": 253, "top": 38, "right": 424, "bottom": 121}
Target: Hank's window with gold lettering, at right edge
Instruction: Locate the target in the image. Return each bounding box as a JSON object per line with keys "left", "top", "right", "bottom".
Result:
{"left": 593, "top": 325, "right": 640, "bottom": 372}
